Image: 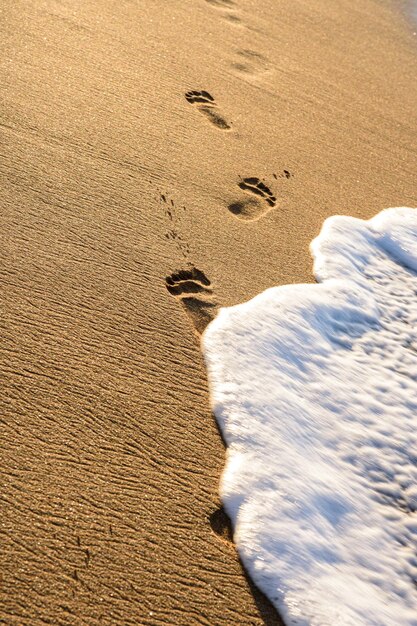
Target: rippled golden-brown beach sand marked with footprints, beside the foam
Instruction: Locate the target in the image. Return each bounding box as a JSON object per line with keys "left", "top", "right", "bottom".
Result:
{"left": 0, "top": 0, "right": 417, "bottom": 626}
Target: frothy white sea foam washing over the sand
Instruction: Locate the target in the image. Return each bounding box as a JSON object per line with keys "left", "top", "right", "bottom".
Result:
{"left": 203, "top": 209, "right": 417, "bottom": 626}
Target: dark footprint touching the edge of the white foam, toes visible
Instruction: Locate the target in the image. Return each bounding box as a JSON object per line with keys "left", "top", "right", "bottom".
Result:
{"left": 165, "top": 267, "right": 217, "bottom": 334}
